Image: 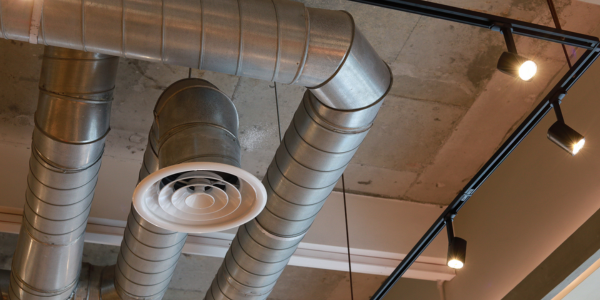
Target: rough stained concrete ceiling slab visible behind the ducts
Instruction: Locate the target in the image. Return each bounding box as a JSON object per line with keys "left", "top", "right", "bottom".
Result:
{"left": 0, "top": 0, "right": 600, "bottom": 204}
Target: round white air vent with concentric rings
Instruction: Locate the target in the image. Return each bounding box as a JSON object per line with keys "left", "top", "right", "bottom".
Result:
{"left": 133, "top": 162, "right": 267, "bottom": 233}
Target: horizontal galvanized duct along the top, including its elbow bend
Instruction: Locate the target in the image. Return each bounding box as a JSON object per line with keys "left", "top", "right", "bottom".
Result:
{"left": 0, "top": 0, "right": 390, "bottom": 110}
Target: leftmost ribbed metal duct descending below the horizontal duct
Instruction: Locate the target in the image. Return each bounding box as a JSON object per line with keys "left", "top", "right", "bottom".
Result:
{"left": 10, "top": 47, "right": 119, "bottom": 300}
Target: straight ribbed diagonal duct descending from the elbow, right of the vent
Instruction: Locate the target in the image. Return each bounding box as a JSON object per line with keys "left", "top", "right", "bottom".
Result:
{"left": 205, "top": 91, "right": 383, "bottom": 300}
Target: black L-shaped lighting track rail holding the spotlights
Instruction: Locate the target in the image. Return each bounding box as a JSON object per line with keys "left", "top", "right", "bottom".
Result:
{"left": 350, "top": 0, "right": 600, "bottom": 300}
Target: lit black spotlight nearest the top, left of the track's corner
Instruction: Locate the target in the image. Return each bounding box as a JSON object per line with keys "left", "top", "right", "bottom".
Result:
{"left": 497, "top": 26, "right": 537, "bottom": 81}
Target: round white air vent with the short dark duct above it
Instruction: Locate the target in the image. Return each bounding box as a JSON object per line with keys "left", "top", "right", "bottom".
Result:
{"left": 133, "top": 79, "right": 266, "bottom": 233}
